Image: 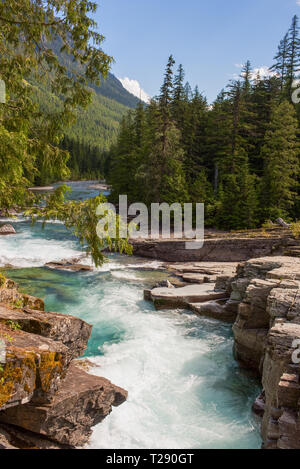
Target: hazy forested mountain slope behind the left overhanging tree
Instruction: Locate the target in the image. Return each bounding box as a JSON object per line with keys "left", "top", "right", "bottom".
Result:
{"left": 29, "top": 41, "right": 139, "bottom": 182}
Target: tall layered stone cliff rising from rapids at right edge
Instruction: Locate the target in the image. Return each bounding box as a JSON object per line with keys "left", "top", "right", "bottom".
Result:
{"left": 219, "top": 257, "right": 300, "bottom": 449}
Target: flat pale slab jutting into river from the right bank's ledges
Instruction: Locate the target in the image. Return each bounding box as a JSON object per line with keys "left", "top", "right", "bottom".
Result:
{"left": 151, "top": 284, "right": 226, "bottom": 309}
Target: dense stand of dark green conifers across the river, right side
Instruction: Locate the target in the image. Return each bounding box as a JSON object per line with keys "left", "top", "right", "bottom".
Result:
{"left": 108, "top": 17, "right": 300, "bottom": 230}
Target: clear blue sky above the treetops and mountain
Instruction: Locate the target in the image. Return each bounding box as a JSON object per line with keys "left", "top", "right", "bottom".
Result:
{"left": 96, "top": 0, "right": 300, "bottom": 102}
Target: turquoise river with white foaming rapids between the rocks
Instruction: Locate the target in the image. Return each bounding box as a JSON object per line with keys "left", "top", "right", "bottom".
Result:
{"left": 0, "top": 181, "right": 261, "bottom": 449}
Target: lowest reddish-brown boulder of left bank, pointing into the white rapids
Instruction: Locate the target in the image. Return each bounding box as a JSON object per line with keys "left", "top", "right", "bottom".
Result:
{"left": 0, "top": 364, "right": 127, "bottom": 446}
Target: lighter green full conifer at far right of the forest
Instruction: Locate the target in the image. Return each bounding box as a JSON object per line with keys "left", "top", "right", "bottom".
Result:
{"left": 261, "top": 101, "right": 299, "bottom": 219}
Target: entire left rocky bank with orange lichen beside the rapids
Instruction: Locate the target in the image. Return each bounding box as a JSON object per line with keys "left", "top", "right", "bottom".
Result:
{"left": 0, "top": 281, "right": 127, "bottom": 449}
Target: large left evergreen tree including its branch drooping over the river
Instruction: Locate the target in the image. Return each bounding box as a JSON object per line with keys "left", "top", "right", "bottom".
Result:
{"left": 0, "top": 0, "right": 134, "bottom": 265}
